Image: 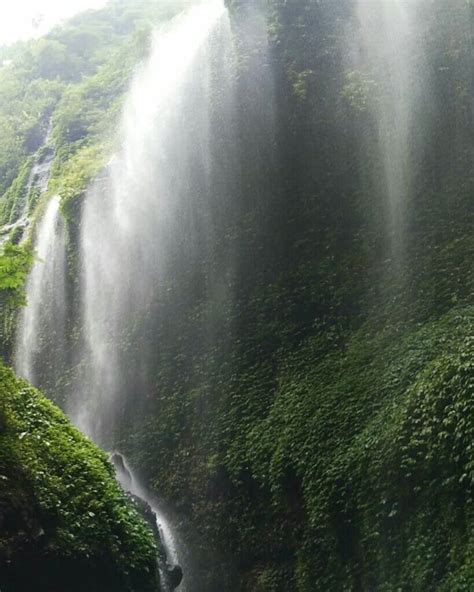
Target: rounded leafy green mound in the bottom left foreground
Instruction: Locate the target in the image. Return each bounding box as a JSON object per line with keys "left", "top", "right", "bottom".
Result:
{"left": 0, "top": 366, "right": 159, "bottom": 592}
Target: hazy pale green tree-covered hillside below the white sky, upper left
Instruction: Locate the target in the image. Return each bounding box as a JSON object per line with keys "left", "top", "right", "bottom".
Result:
{"left": 0, "top": 0, "right": 193, "bottom": 229}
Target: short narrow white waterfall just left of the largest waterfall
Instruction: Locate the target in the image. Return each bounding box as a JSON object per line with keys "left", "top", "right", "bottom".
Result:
{"left": 14, "top": 196, "right": 66, "bottom": 389}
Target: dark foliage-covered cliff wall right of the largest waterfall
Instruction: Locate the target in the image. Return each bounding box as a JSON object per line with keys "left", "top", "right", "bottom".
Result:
{"left": 115, "top": 0, "right": 474, "bottom": 592}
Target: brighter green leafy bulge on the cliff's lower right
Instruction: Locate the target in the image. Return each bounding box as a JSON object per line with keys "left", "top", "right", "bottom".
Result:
{"left": 225, "top": 307, "right": 474, "bottom": 592}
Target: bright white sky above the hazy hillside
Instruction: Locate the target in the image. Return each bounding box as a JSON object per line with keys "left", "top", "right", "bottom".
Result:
{"left": 0, "top": 0, "right": 106, "bottom": 45}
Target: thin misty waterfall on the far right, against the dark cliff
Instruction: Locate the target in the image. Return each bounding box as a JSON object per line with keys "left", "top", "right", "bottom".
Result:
{"left": 355, "top": 0, "right": 427, "bottom": 270}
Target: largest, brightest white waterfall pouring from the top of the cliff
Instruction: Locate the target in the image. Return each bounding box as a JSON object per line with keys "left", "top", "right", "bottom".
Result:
{"left": 69, "top": 1, "right": 230, "bottom": 439}
